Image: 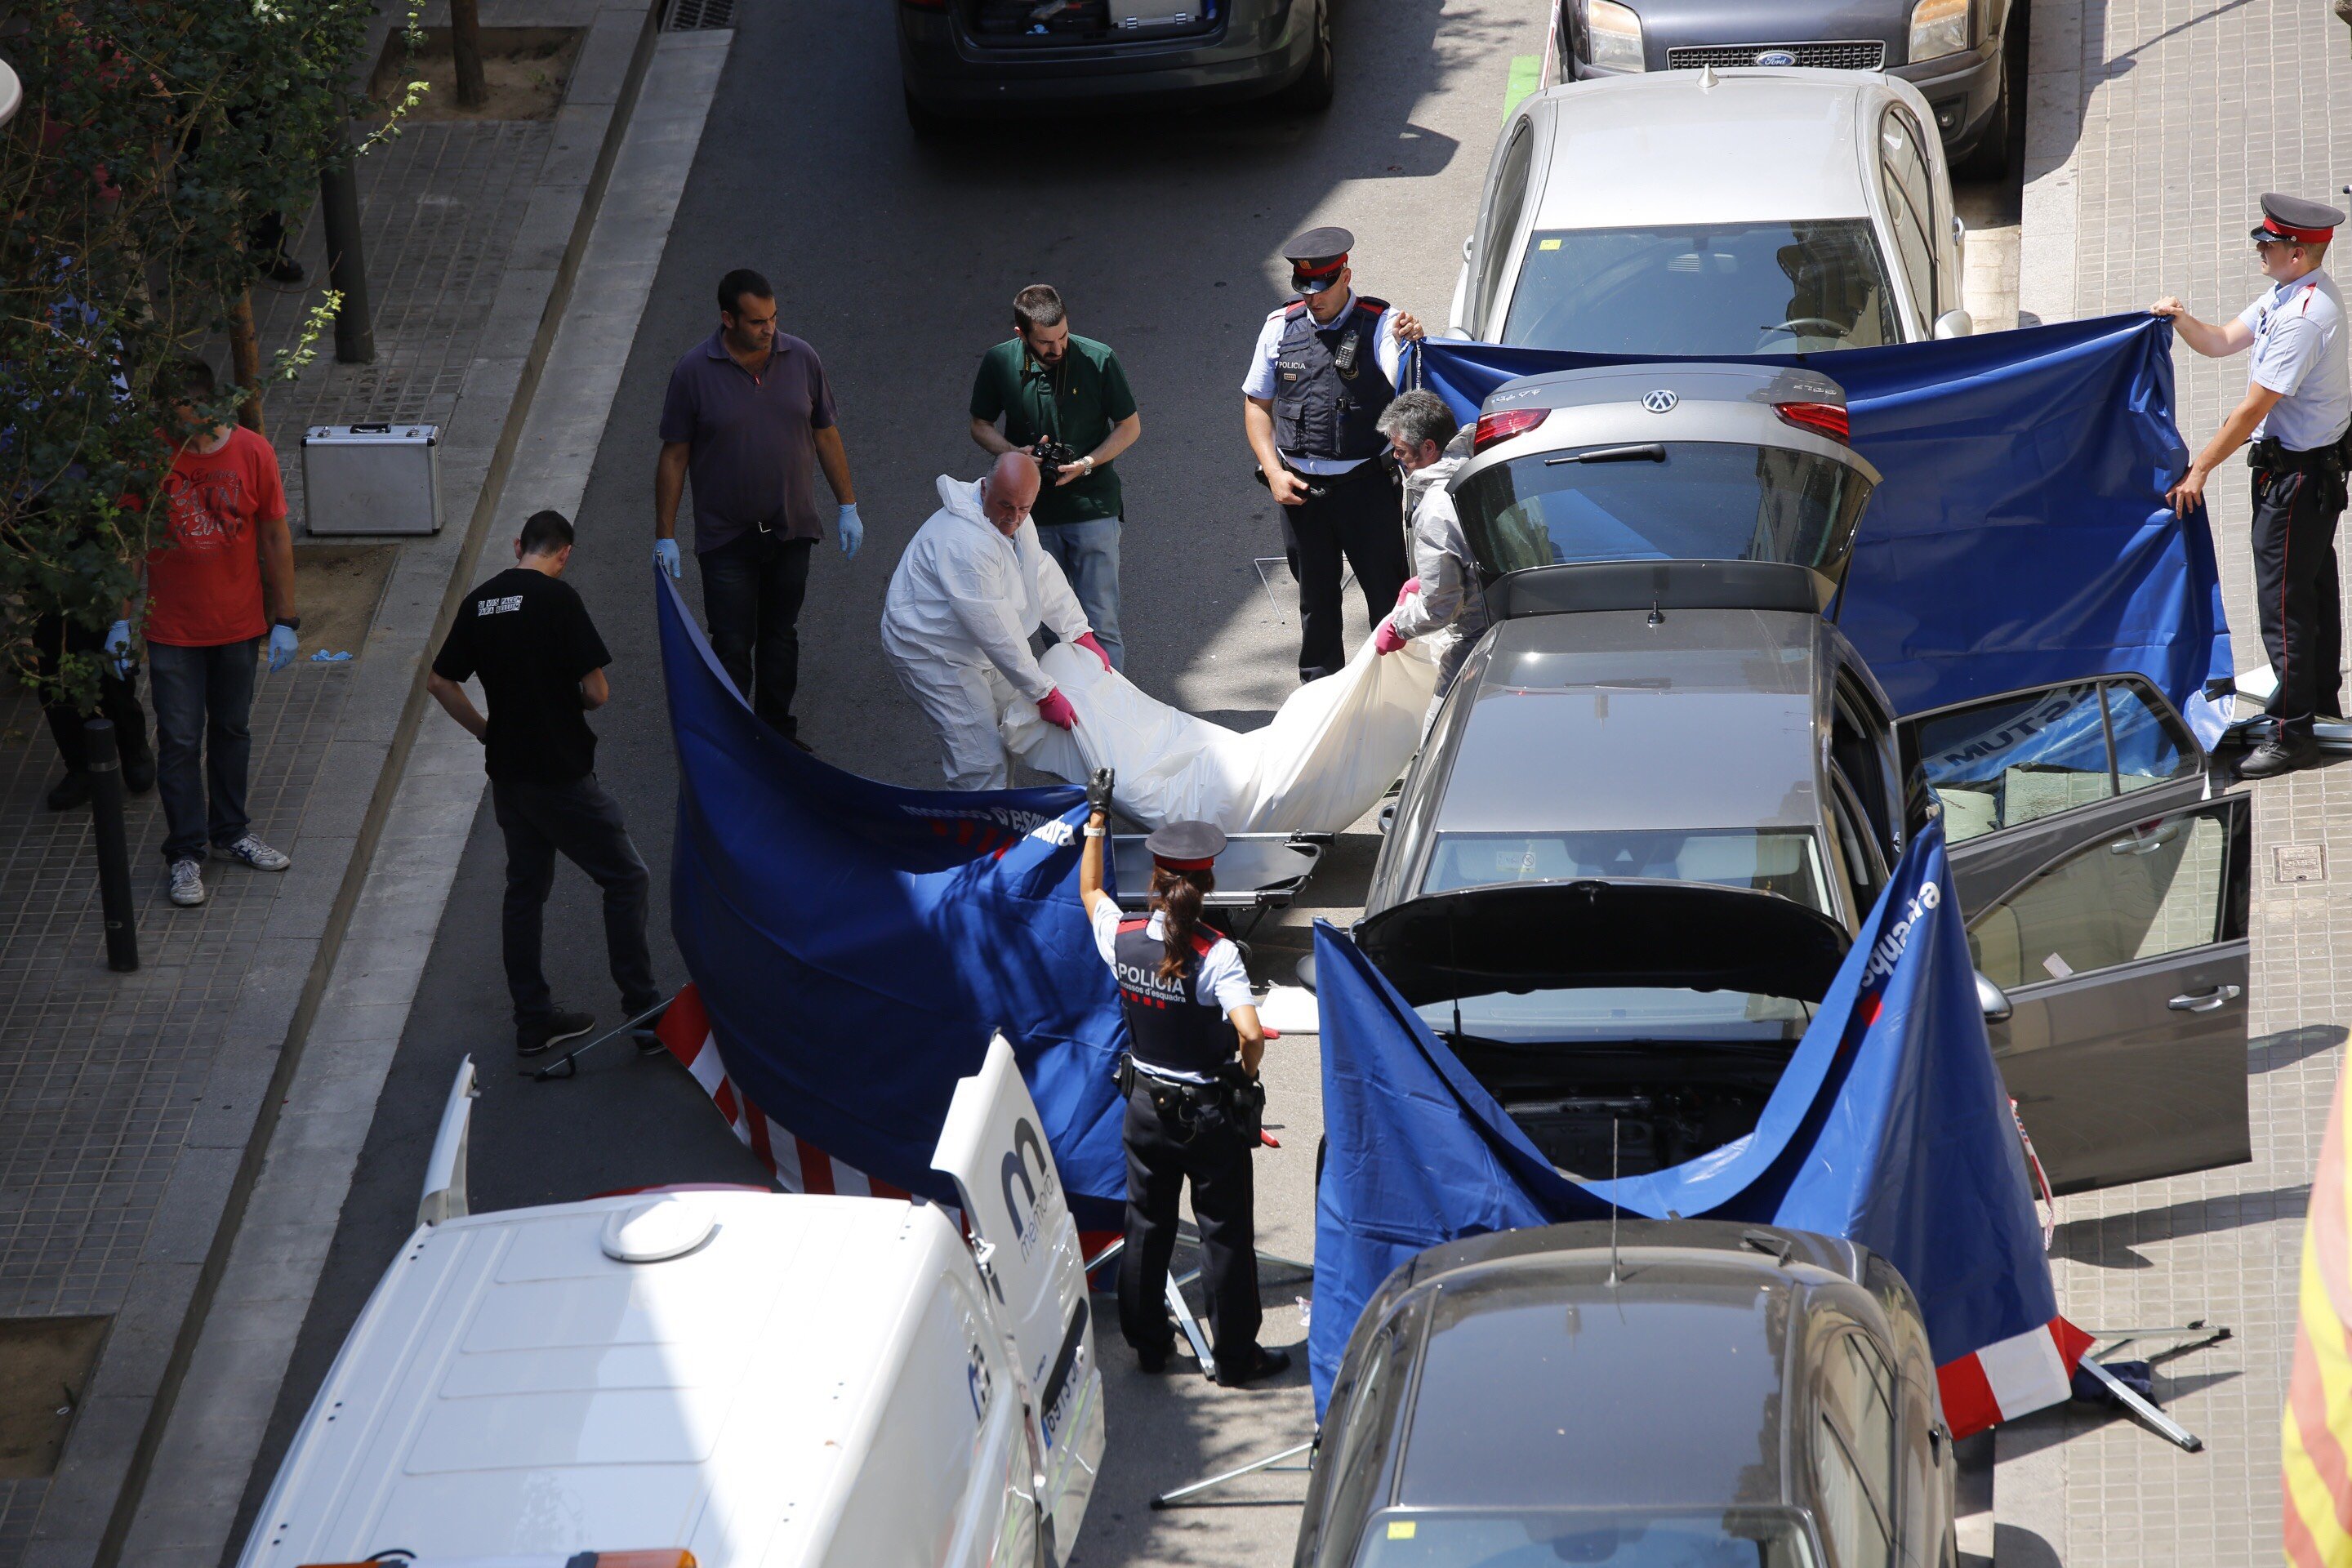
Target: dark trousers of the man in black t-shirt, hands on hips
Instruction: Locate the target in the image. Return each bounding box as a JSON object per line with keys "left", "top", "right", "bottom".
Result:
{"left": 489, "top": 773, "right": 661, "bottom": 1027}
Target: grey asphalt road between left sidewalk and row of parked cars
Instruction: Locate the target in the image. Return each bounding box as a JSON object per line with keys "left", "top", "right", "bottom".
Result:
{"left": 230, "top": 0, "right": 1545, "bottom": 1566}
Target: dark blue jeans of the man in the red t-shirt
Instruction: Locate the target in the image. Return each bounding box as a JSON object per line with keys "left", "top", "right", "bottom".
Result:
{"left": 148, "top": 637, "right": 261, "bottom": 861}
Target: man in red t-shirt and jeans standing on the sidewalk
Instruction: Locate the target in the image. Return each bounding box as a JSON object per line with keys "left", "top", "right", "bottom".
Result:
{"left": 146, "top": 358, "right": 301, "bottom": 905}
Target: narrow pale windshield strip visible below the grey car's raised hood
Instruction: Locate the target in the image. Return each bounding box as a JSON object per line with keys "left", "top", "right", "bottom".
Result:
{"left": 1414, "top": 985, "right": 1813, "bottom": 1046}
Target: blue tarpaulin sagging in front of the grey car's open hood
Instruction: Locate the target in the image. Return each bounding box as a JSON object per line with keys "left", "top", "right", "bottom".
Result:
{"left": 1307, "top": 822, "right": 2065, "bottom": 1413}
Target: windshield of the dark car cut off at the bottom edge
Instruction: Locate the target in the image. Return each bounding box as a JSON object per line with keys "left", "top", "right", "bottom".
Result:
{"left": 1355, "top": 1507, "right": 1813, "bottom": 1568}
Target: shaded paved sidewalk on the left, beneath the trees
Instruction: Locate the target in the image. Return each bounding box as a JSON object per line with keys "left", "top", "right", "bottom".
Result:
{"left": 0, "top": 0, "right": 677, "bottom": 1568}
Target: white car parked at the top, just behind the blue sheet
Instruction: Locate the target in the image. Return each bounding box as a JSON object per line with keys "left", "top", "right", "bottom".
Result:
{"left": 1449, "top": 68, "right": 1971, "bottom": 358}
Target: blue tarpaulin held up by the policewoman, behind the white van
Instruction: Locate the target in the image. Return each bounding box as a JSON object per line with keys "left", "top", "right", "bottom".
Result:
{"left": 654, "top": 571, "right": 1127, "bottom": 1229}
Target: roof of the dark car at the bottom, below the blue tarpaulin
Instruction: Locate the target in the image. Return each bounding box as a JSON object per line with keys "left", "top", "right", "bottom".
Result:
{"left": 1390, "top": 1220, "right": 1884, "bottom": 1509}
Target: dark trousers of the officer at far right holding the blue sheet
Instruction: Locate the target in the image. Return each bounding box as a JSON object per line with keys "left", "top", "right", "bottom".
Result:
{"left": 2253, "top": 463, "right": 2345, "bottom": 733}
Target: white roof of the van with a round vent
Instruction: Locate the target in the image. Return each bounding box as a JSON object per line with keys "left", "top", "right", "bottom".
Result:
{"left": 243, "top": 1192, "right": 962, "bottom": 1568}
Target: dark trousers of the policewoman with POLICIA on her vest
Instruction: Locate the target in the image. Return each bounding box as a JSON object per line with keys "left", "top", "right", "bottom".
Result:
{"left": 1120, "top": 1084, "right": 1258, "bottom": 1364}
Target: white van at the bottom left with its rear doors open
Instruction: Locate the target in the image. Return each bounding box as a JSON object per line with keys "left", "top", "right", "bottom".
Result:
{"left": 240, "top": 1039, "right": 1103, "bottom": 1568}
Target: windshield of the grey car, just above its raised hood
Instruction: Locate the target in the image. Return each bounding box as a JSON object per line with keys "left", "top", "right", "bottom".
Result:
{"left": 1421, "top": 827, "right": 1833, "bottom": 915}
